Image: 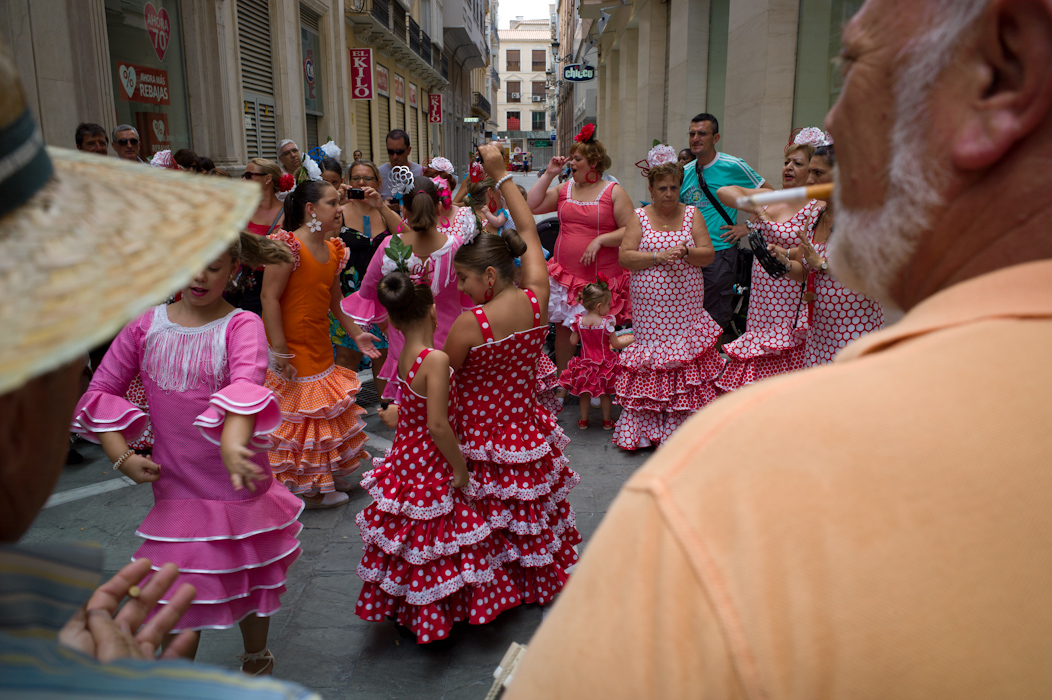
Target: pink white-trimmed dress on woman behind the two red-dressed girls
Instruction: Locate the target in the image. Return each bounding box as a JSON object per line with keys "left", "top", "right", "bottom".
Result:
{"left": 342, "top": 206, "right": 476, "bottom": 401}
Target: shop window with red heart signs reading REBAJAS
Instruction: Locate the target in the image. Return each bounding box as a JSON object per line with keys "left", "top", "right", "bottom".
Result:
{"left": 106, "top": 0, "right": 194, "bottom": 159}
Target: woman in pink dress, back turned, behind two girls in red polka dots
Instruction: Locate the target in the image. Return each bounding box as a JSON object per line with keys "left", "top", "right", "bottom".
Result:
{"left": 343, "top": 178, "right": 477, "bottom": 403}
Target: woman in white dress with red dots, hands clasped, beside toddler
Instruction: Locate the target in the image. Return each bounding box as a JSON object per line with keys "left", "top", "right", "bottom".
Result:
{"left": 613, "top": 155, "right": 723, "bottom": 449}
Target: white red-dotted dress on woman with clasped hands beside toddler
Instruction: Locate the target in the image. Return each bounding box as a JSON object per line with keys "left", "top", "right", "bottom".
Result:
{"left": 613, "top": 205, "right": 723, "bottom": 449}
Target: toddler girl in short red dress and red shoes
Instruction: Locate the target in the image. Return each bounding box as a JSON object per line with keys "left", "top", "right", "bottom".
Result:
{"left": 559, "top": 282, "right": 632, "bottom": 431}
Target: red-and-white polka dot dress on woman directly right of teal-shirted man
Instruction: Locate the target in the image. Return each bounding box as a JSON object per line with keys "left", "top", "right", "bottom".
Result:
{"left": 716, "top": 200, "right": 818, "bottom": 392}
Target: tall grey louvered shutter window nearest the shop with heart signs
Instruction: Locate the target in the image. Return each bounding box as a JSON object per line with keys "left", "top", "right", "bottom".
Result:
{"left": 237, "top": 0, "right": 278, "bottom": 160}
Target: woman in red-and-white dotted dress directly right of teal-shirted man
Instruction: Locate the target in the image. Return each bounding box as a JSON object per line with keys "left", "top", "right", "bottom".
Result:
{"left": 716, "top": 138, "right": 821, "bottom": 392}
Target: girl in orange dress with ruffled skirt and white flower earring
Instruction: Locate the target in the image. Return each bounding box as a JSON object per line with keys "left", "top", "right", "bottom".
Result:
{"left": 262, "top": 180, "right": 379, "bottom": 508}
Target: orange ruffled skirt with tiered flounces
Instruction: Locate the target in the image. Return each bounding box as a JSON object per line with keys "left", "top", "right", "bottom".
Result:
{"left": 266, "top": 364, "right": 365, "bottom": 494}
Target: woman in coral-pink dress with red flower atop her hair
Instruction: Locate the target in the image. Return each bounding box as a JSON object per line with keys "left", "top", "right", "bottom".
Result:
{"left": 527, "top": 124, "right": 632, "bottom": 383}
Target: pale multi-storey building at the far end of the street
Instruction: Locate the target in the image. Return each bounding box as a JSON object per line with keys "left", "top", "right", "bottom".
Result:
{"left": 497, "top": 17, "right": 553, "bottom": 167}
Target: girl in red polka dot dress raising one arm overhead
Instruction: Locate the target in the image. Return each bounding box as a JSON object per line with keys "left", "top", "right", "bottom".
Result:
{"left": 445, "top": 145, "right": 581, "bottom": 603}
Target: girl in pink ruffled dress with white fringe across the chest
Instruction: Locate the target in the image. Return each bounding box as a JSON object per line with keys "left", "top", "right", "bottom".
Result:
{"left": 73, "top": 233, "right": 303, "bottom": 675}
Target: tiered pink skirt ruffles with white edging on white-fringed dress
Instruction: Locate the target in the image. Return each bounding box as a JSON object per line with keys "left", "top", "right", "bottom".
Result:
{"left": 133, "top": 482, "right": 303, "bottom": 632}
